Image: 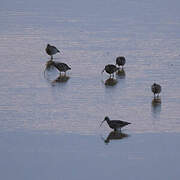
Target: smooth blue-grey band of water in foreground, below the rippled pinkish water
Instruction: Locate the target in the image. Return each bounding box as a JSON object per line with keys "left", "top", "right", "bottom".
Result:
{"left": 0, "top": 133, "right": 180, "bottom": 180}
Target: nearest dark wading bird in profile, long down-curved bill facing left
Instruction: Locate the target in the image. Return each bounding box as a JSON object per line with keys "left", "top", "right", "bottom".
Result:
{"left": 100, "top": 116, "right": 131, "bottom": 131}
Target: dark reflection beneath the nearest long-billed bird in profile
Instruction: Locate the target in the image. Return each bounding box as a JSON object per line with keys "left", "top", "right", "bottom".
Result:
{"left": 102, "top": 131, "right": 129, "bottom": 144}
